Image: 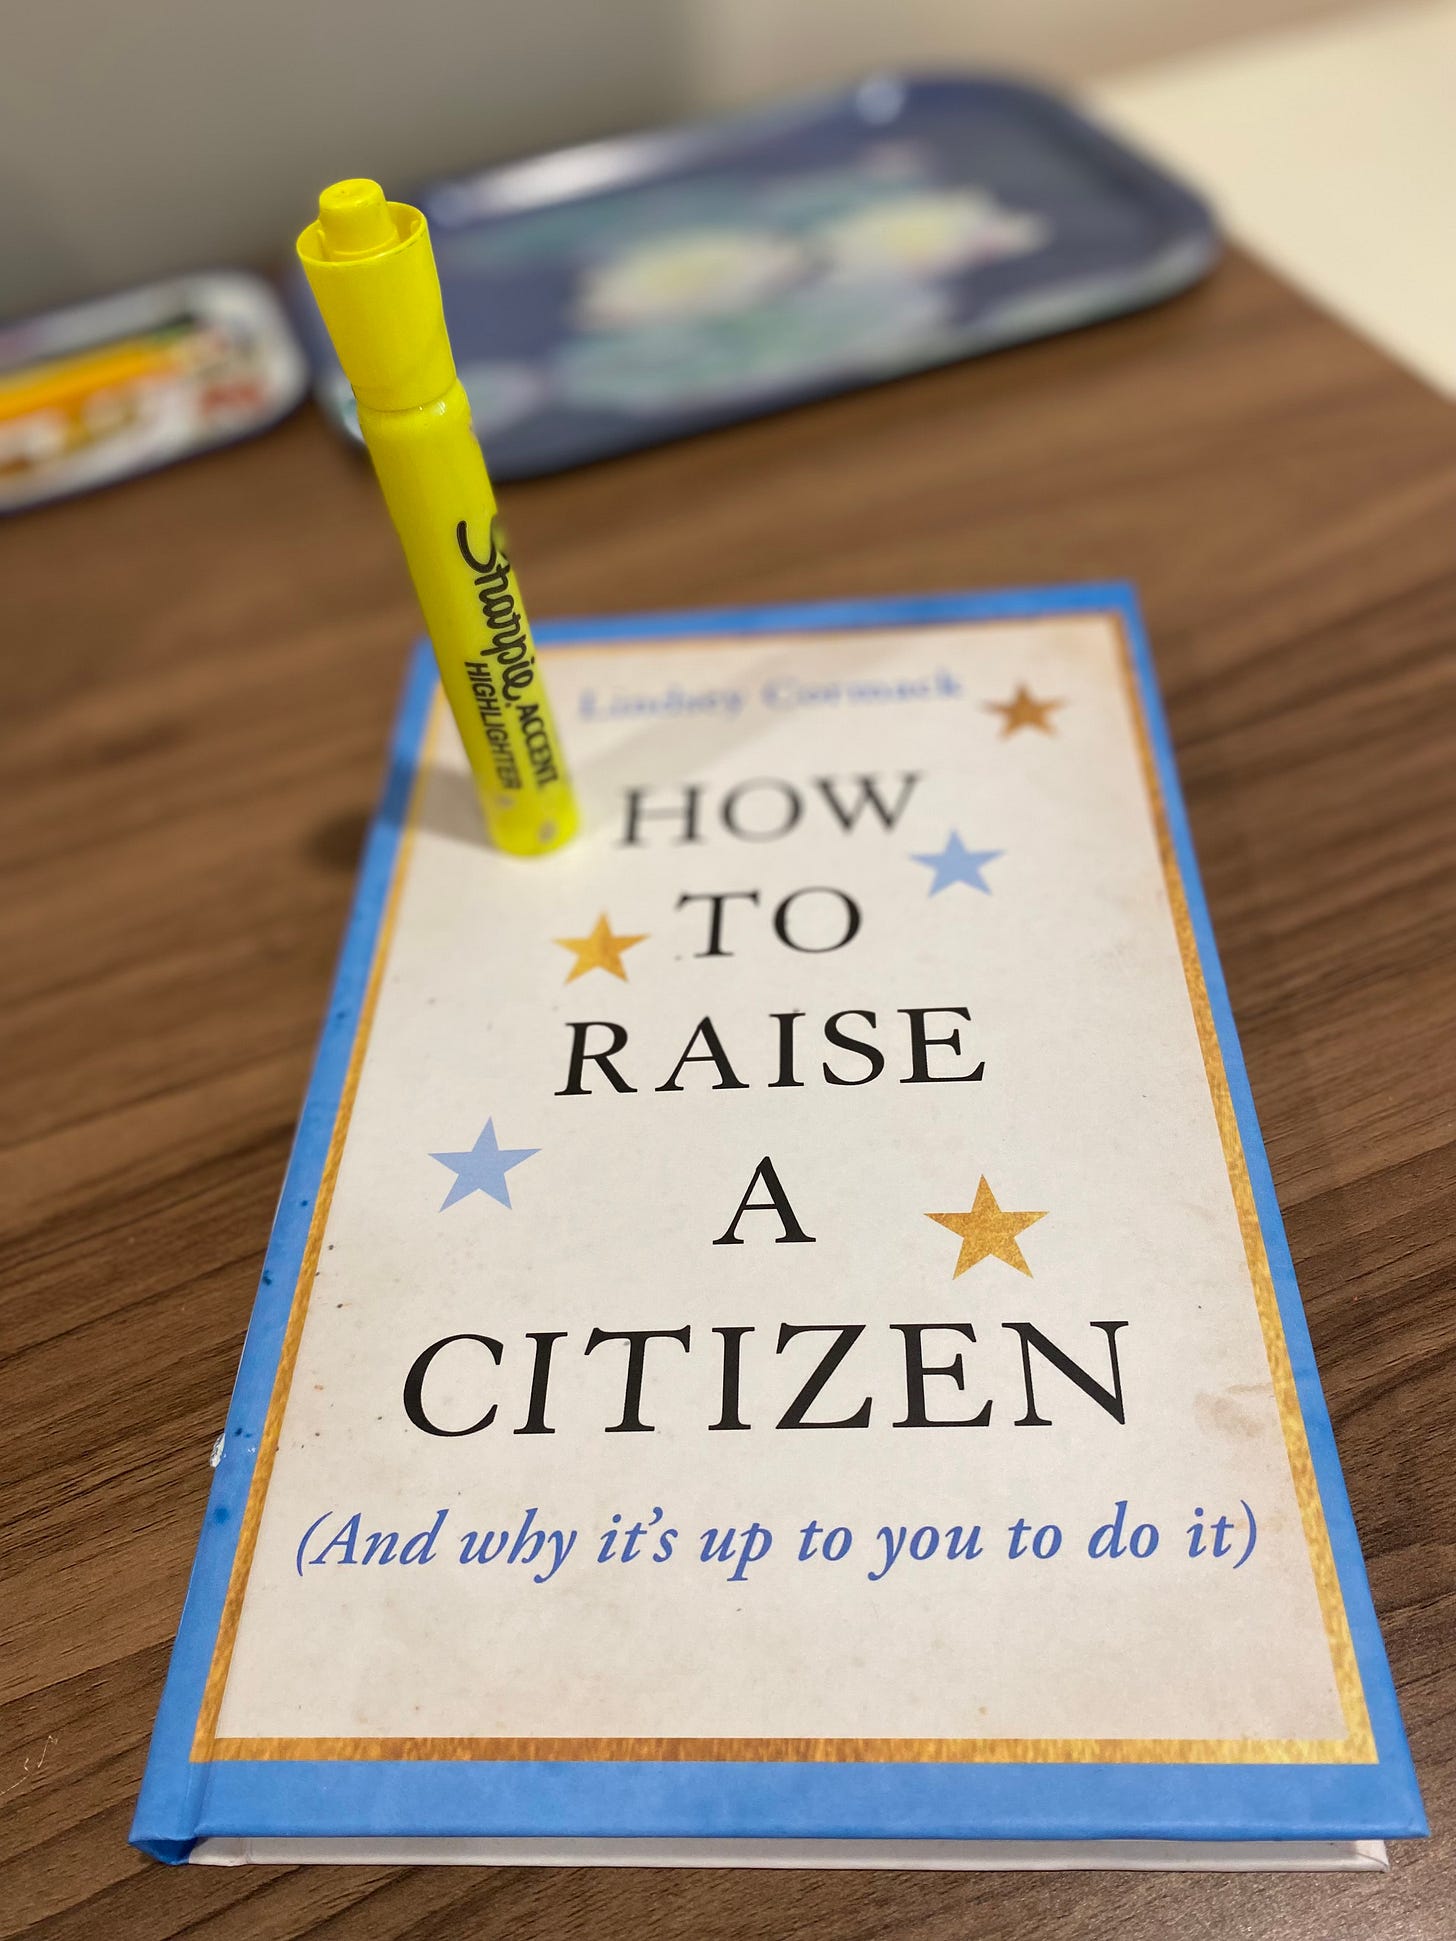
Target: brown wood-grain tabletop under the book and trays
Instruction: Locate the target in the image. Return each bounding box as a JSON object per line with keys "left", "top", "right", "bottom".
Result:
{"left": 0, "top": 260, "right": 1456, "bottom": 1941}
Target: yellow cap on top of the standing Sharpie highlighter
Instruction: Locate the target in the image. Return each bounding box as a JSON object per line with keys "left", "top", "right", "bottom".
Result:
{"left": 299, "top": 179, "right": 454, "bottom": 411}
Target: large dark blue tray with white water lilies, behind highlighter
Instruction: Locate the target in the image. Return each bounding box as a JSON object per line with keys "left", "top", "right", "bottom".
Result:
{"left": 293, "top": 76, "right": 1219, "bottom": 477}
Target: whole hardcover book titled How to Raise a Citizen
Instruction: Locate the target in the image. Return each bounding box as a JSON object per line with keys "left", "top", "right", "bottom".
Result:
{"left": 132, "top": 586, "right": 1425, "bottom": 1867}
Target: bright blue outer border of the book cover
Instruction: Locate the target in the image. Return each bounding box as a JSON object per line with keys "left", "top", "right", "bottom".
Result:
{"left": 132, "top": 582, "right": 1427, "bottom": 1861}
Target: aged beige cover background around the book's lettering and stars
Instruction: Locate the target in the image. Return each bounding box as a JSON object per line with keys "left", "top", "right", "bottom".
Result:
{"left": 219, "top": 621, "right": 1343, "bottom": 1739}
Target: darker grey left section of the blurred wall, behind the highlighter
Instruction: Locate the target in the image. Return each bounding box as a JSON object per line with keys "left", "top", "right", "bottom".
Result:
{"left": 0, "top": 0, "right": 689, "bottom": 314}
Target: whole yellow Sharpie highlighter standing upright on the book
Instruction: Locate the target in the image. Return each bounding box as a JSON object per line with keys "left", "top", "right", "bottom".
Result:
{"left": 299, "top": 181, "right": 577, "bottom": 856}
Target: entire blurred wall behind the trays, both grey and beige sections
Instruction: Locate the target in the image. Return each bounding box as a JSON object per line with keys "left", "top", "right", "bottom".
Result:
{"left": 0, "top": 0, "right": 1366, "bottom": 316}
